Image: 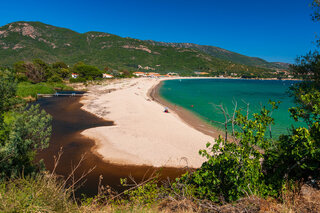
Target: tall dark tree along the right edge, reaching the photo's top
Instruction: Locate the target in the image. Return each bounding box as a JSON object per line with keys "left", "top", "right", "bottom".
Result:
{"left": 265, "top": 0, "right": 320, "bottom": 189}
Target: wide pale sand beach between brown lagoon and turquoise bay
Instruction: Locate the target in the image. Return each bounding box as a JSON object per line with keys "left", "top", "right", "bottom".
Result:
{"left": 81, "top": 78, "right": 214, "bottom": 168}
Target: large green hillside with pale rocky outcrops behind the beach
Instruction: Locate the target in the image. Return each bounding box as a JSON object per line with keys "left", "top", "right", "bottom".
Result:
{"left": 0, "top": 22, "right": 288, "bottom": 77}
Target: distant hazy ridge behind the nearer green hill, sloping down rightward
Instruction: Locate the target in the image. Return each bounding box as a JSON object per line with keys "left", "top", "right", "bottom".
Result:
{"left": 146, "top": 40, "right": 290, "bottom": 69}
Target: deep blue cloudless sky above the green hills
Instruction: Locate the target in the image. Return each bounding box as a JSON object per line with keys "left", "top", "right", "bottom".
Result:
{"left": 0, "top": 0, "right": 320, "bottom": 63}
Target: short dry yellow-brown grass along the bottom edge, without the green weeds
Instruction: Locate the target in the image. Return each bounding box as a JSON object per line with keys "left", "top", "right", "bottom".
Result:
{"left": 0, "top": 175, "right": 320, "bottom": 213}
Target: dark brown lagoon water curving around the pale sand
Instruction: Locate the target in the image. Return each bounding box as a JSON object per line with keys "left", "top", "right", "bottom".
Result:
{"left": 36, "top": 94, "right": 185, "bottom": 197}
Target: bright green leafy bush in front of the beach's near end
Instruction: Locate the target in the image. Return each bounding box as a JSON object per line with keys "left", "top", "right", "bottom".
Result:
{"left": 185, "top": 104, "right": 273, "bottom": 202}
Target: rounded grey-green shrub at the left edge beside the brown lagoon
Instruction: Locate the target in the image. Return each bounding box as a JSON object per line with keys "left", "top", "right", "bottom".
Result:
{"left": 0, "top": 105, "right": 51, "bottom": 178}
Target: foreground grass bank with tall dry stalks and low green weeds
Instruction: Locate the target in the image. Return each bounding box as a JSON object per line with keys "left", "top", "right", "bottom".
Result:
{"left": 0, "top": 147, "right": 320, "bottom": 213}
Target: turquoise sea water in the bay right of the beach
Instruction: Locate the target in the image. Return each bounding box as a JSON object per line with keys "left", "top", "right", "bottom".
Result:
{"left": 160, "top": 79, "right": 301, "bottom": 135}
